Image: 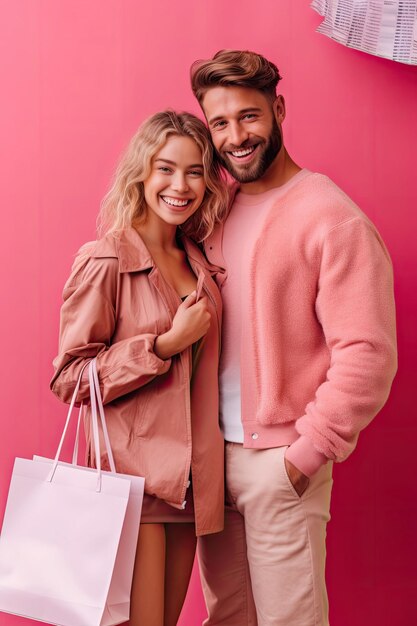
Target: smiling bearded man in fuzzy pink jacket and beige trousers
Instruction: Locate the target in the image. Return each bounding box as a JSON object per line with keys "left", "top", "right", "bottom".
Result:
{"left": 191, "top": 50, "right": 396, "bottom": 626}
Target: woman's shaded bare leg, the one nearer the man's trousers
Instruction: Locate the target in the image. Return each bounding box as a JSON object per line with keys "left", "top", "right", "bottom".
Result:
{"left": 162, "top": 524, "right": 197, "bottom": 626}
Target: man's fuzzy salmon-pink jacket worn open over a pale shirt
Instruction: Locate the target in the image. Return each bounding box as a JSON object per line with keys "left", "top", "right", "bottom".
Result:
{"left": 206, "top": 170, "right": 397, "bottom": 476}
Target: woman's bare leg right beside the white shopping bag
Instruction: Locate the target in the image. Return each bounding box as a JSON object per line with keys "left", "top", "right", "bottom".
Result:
{"left": 129, "top": 524, "right": 165, "bottom": 626}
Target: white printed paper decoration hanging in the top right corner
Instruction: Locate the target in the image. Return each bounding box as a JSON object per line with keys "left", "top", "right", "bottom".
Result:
{"left": 311, "top": 0, "right": 417, "bottom": 65}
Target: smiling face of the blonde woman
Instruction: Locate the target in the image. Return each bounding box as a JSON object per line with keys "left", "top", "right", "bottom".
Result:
{"left": 143, "top": 135, "right": 206, "bottom": 226}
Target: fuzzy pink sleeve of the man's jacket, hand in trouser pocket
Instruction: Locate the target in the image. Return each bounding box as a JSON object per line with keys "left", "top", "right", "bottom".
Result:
{"left": 287, "top": 217, "right": 397, "bottom": 475}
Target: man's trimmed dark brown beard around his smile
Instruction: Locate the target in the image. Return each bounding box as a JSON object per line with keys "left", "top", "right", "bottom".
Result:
{"left": 218, "top": 119, "right": 282, "bottom": 183}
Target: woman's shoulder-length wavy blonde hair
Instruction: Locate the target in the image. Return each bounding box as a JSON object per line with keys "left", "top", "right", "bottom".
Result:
{"left": 98, "top": 110, "right": 228, "bottom": 242}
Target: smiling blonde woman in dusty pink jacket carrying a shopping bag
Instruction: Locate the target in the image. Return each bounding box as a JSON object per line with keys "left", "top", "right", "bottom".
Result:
{"left": 51, "top": 111, "right": 226, "bottom": 626}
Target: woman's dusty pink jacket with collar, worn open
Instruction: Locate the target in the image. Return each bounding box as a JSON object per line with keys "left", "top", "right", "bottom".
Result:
{"left": 51, "top": 228, "right": 224, "bottom": 535}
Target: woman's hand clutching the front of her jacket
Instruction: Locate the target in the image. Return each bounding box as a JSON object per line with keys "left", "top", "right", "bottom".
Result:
{"left": 154, "top": 291, "right": 211, "bottom": 359}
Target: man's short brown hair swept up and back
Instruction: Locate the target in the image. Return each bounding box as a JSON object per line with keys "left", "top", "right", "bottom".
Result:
{"left": 191, "top": 50, "right": 281, "bottom": 104}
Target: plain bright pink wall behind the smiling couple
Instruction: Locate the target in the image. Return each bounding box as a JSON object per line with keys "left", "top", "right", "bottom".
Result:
{"left": 0, "top": 0, "right": 417, "bottom": 626}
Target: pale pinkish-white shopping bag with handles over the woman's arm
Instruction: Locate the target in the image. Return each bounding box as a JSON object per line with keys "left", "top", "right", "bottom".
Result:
{"left": 0, "top": 360, "right": 144, "bottom": 626}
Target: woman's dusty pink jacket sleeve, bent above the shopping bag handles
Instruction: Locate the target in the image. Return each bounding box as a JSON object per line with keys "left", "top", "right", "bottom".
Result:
{"left": 51, "top": 257, "right": 171, "bottom": 403}
